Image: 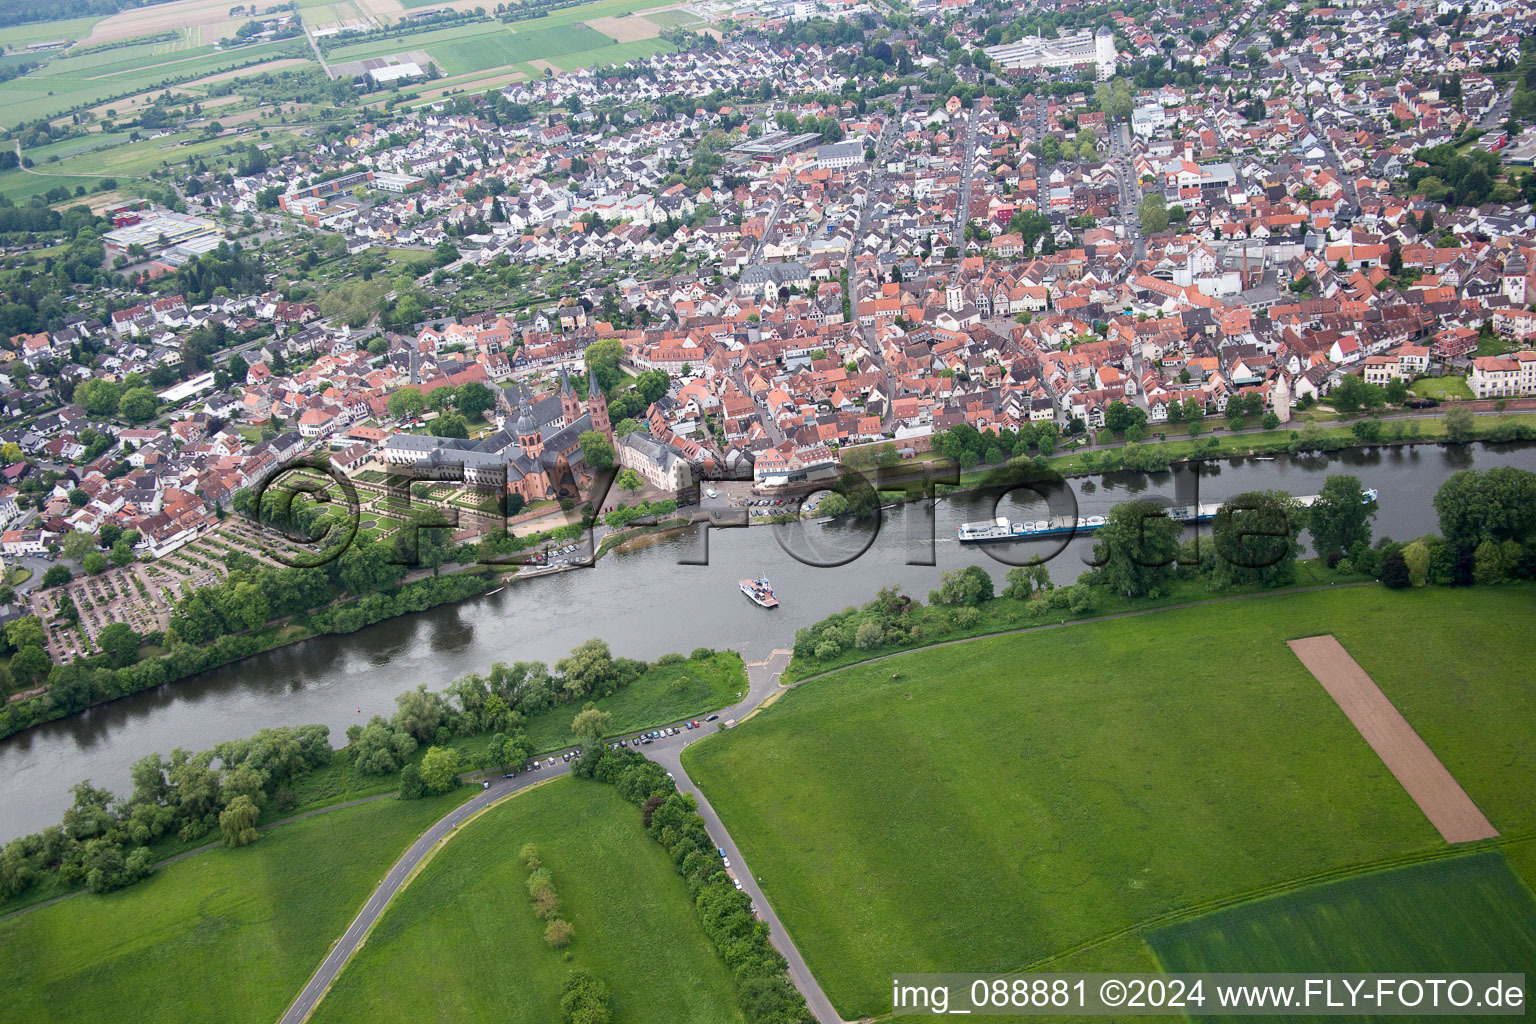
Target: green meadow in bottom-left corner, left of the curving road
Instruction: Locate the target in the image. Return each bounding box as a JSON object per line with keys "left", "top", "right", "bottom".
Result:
{"left": 0, "top": 789, "right": 475, "bottom": 1024}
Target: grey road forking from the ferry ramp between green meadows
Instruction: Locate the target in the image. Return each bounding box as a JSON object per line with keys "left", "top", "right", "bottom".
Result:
{"left": 281, "top": 651, "right": 842, "bottom": 1024}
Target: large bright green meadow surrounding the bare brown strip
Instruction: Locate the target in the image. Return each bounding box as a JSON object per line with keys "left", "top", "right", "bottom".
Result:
{"left": 684, "top": 586, "right": 1536, "bottom": 1019}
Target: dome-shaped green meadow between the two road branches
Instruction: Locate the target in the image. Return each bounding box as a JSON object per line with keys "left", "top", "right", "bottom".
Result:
{"left": 310, "top": 778, "right": 740, "bottom": 1024}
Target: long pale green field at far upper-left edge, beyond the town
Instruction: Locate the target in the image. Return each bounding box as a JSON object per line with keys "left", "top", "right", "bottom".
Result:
{"left": 0, "top": 40, "right": 307, "bottom": 126}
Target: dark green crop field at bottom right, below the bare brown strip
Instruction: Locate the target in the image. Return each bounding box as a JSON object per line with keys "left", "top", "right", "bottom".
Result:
{"left": 1147, "top": 851, "right": 1536, "bottom": 975}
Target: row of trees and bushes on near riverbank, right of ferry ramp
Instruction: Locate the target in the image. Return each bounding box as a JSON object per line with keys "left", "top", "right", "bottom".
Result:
{"left": 794, "top": 467, "right": 1536, "bottom": 668}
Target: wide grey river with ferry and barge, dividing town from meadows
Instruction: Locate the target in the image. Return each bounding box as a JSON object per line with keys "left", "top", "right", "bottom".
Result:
{"left": 0, "top": 445, "right": 1536, "bottom": 841}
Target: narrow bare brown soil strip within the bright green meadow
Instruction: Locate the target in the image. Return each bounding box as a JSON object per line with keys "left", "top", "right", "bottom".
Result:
{"left": 1289, "top": 636, "right": 1498, "bottom": 843}
